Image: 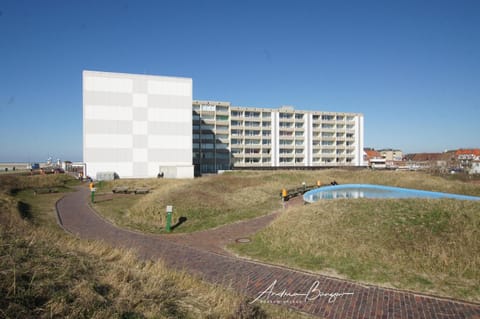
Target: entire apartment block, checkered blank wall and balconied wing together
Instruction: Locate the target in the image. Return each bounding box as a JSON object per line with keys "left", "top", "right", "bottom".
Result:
{"left": 83, "top": 71, "right": 364, "bottom": 178}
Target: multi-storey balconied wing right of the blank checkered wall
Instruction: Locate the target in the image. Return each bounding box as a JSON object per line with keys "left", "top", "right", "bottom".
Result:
{"left": 193, "top": 101, "right": 364, "bottom": 173}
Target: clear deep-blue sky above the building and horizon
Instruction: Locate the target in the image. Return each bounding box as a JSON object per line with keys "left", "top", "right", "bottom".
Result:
{"left": 0, "top": 0, "right": 480, "bottom": 162}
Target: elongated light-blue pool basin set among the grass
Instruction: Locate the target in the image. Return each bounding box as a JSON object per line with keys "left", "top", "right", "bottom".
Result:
{"left": 303, "top": 184, "right": 480, "bottom": 203}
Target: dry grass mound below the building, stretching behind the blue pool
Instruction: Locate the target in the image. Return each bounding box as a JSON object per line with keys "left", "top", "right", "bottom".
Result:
{"left": 95, "top": 169, "right": 480, "bottom": 233}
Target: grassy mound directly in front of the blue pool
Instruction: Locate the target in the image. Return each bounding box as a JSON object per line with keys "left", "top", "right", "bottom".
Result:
{"left": 230, "top": 199, "right": 480, "bottom": 302}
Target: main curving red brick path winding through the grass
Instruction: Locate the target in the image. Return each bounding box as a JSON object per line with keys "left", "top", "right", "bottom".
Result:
{"left": 57, "top": 188, "right": 480, "bottom": 319}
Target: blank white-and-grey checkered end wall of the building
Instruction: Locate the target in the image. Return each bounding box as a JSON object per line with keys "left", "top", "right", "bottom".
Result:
{"left": 83, "top": 71, "right": 193, "bottom": 178}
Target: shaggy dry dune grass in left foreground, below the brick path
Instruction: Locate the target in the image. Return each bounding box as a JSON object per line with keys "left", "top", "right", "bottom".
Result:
{"left": 0, "top": 176, "right": 308, "bottom": 318}
